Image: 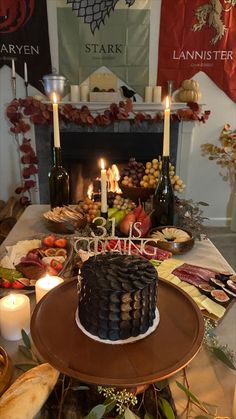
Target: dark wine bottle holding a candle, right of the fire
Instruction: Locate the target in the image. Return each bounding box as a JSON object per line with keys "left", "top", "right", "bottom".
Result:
{"left": 151, "top": 156, "right": 175, "bottom": 227}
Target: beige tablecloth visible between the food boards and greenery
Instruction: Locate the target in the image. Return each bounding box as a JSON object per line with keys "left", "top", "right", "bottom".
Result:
{"left": 0, "top": 205, "right": 236, "bottom": 419}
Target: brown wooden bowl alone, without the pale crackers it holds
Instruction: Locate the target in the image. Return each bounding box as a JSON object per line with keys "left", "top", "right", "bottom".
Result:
{"left": 148, "top": 226, "right": 194, "bottom": 255}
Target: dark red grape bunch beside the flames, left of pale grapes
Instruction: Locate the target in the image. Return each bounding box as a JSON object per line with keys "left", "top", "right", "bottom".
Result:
{"left": 121, "top": 157, "right": 145, "bottom": 186}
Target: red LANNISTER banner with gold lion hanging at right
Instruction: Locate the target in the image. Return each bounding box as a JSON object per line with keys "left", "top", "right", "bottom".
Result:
{"left": 157, "top": 0, "right": 236, "bottom": 102}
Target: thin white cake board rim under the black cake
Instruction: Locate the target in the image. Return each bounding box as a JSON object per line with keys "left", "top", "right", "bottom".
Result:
{"left": 75, "top": 308, "right": 160, "bottom": 345}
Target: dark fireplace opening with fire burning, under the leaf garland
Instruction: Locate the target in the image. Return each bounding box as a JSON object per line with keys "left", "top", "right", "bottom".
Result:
{"left": 35, "top": 121, "right": 179, "bottom": 204}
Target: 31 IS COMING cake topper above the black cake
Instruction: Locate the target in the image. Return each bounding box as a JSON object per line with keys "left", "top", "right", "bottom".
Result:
{"left": 74, "top": 217, "right": 158, "bottom": 259}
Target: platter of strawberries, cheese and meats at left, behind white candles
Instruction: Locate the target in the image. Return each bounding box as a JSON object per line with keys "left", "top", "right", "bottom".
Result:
{"left": 0, "top": 234, "right": 73, "bottom": 296}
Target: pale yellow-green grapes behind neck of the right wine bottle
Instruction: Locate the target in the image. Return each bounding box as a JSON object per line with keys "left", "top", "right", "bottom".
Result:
{"left": 140, "top": 159, "right": 186, "bottom": 192}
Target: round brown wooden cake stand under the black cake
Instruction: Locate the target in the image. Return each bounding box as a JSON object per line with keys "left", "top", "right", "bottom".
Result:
{"left": 31, "top": 280, "right": 204, "bottom": 387}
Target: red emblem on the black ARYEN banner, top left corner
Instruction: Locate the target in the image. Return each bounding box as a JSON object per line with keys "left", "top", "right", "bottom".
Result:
{"left": 0, "top": 0, "right": 35, "bottom": 33}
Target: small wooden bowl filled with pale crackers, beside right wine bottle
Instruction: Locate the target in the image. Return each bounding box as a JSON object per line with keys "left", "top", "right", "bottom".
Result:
{"left": 148, "top": 226, "right": 194, "bottom": 255}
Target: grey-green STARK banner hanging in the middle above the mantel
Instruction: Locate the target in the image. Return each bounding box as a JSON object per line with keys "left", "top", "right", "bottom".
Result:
{"left": 57, "top": 0, "right": 150, "bottom": 95}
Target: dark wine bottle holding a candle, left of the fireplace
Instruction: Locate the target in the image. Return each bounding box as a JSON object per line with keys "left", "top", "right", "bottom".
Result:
{"left": 48, "top": 147, "right": 69, "bottom": 208}
